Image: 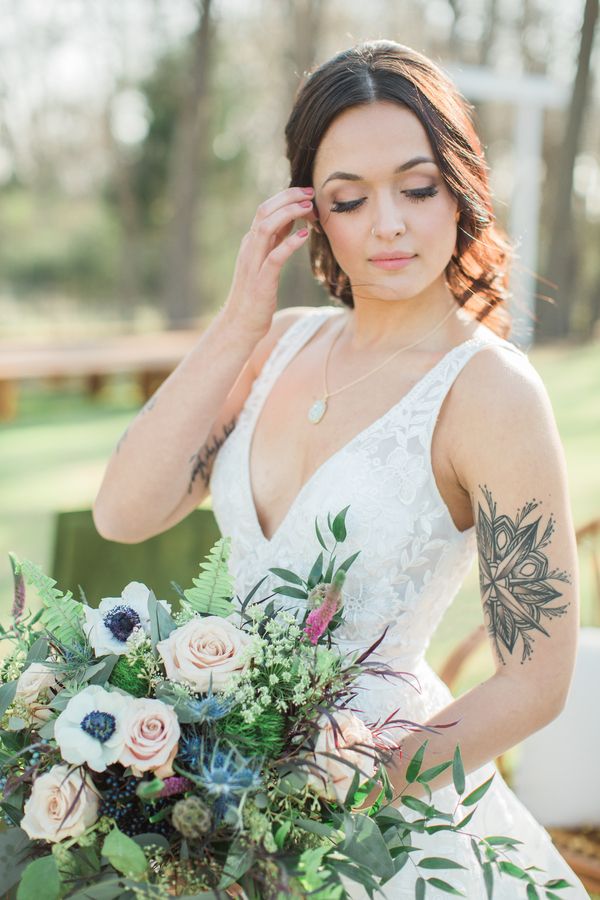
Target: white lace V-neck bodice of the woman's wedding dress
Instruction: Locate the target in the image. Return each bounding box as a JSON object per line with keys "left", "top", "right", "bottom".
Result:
{"left": 210, "top": 307, "right": 524, "bottom": 667}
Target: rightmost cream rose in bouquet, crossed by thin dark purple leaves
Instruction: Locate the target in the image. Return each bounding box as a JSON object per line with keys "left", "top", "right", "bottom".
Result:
{"left": 308, "top": 709, "right": 377, "bottom": 803}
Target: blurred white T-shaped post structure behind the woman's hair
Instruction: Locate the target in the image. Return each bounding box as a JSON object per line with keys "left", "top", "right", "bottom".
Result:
{"left": 444, "top": 66, "right": 569, "bottom": 352}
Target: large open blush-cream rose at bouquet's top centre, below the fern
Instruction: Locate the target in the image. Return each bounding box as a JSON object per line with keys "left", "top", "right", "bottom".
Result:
{"left": 156, "top": 616, "right": 251, "bottom": 691}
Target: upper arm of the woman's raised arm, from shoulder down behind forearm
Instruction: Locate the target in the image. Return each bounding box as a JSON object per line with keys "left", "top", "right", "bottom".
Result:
{"left": 157, "top": 306, "right": 307, "bottom": 531}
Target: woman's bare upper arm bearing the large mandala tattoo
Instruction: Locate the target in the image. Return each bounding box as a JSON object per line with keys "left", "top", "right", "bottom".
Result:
{"left": 453, "top": 348, "right": 579, "bottom": 717}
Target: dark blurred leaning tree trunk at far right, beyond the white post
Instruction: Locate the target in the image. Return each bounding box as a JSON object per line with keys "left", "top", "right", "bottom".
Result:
{"left": 535, "top": 0, "right": 598, "bottom": 341}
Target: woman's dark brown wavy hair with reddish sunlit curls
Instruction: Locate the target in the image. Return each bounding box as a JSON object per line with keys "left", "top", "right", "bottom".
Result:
{"left": 285, "top": 40, "right": 513, "bottom": 338}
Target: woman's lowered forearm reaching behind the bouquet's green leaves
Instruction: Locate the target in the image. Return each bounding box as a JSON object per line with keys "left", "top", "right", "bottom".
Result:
{"left": 365, "top": 672, "right": 559, "bottom": 805}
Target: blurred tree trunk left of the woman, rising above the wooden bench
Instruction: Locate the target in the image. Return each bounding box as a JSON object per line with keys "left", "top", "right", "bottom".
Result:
{"left": 163, "top": 0, "right": 215, "bottom": 328}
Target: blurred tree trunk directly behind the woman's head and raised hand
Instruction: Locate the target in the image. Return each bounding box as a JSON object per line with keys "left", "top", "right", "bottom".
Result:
{"left": 281, "top": 0, "right": 326, "bottom": 306}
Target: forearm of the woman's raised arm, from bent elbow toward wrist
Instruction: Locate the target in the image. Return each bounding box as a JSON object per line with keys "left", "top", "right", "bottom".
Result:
{"left": 94, "top": 311, "right": 259, "bottom": 543}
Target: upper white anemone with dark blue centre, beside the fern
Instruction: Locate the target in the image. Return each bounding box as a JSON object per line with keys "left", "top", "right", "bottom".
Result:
{"left": 84, "top": 581, "right": 169, "bottom": 656}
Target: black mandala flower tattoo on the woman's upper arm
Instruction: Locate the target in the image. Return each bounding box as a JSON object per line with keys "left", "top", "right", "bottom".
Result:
{"left": 476, "top": 485, "right": 571, "bottom": 665}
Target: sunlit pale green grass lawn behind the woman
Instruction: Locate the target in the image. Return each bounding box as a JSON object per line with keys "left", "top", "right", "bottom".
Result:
{"left": 0, "top": 345, "right": 600, "bottom": 691}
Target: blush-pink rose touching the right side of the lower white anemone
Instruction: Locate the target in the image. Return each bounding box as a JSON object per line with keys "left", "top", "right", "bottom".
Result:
{"left": 118, "top": 699, "right": 180, "bottom": 778}
